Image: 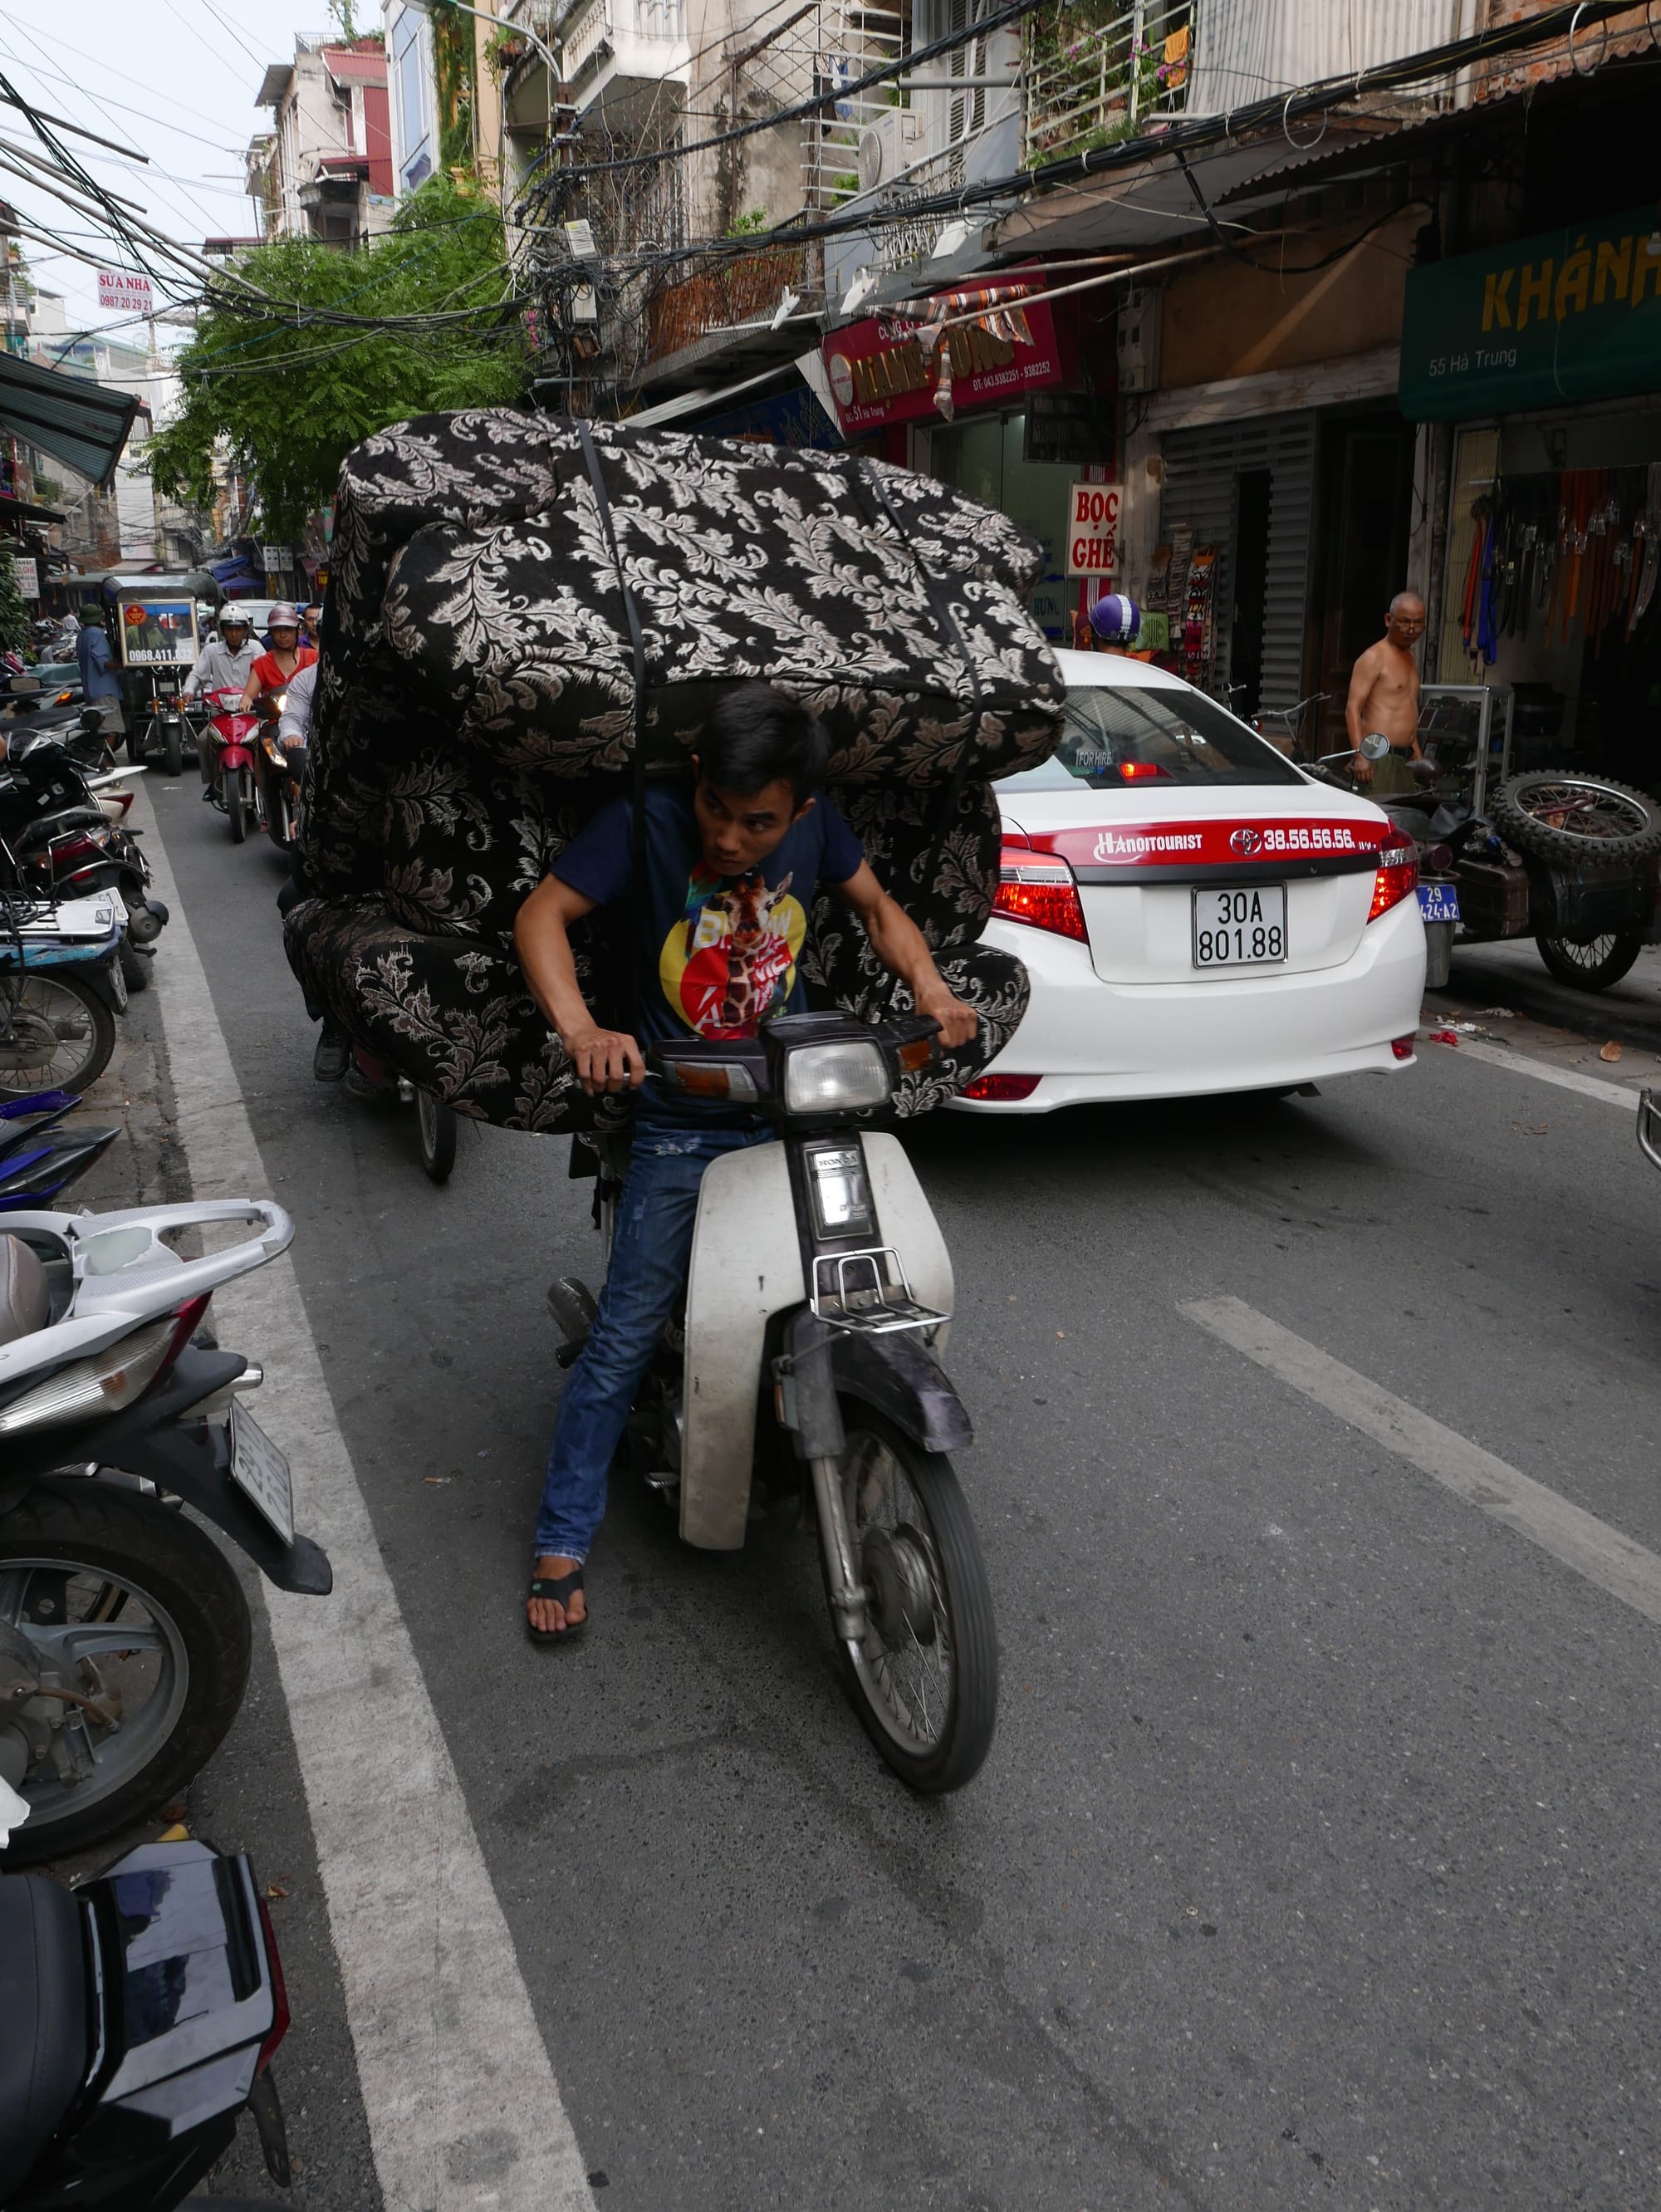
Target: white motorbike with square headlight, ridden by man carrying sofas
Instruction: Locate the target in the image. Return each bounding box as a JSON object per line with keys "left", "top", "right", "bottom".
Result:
{"left": 548, "top": 1013, "right": 997, "bottom": 1794}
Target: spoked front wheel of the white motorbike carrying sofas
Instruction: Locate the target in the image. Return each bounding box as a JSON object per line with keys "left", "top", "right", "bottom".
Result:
{"left": 822, "top": 1398, "right": 997, "bottom": 1796}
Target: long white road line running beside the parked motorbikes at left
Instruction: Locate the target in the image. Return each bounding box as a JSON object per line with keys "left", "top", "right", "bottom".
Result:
{"left": 140, "top": 783, "right": 595, "bottom": 2212}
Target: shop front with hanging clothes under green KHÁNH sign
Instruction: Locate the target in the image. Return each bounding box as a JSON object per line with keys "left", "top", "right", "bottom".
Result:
{"left": 1402, "top": 206, "right": 1661, "bottom": 790}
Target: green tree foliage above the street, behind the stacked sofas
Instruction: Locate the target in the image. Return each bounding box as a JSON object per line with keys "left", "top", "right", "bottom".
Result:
{"left": 148, "top": 174, "right": 528, "bottom": 537}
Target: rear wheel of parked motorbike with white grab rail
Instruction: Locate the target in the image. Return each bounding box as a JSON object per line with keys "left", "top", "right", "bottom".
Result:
{"left": 0, "top": 1478, "right": 252, "bottom": 1867}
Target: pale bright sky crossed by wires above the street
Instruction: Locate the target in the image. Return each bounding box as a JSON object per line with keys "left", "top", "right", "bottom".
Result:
{"left": 0, "top": 0, "right": 347, "bottom": 343}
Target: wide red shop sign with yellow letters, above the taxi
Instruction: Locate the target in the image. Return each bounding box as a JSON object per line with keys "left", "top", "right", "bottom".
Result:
{"left": 823, "top": 278, "right": 1066, "bottom": 436}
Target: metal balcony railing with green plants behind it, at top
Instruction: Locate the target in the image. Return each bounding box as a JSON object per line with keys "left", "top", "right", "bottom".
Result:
{"left": 1022, "top": 0, "right": 1194, "bottom": 168}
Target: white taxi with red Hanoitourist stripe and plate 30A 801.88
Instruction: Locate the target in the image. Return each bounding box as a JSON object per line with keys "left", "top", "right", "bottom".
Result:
{"left": 958, "top": 653, "right": 1424, "bottom": 1112}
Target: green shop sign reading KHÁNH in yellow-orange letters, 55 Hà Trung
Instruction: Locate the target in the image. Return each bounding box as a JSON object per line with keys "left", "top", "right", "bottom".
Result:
{"left": 1400, "top": 206, "right": 1661, "bottom": 423}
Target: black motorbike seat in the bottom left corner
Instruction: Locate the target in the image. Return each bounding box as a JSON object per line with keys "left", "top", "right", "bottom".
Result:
{"left": 0, "top": 1874, "right": 89, "bottom": 2203}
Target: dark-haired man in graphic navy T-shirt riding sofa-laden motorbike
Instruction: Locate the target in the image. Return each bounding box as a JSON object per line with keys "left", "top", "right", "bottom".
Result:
{"left": 513, "top": 684, "right": 977, "bottom": 1644}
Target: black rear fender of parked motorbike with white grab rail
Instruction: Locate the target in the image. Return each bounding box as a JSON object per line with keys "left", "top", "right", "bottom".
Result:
{"left": 7, "top": 1349, "right": 334, "bottom": 1597}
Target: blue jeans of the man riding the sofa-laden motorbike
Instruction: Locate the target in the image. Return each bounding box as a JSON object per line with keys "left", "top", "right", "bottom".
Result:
{"left": 535, "top": 1121, "right": 772, "bottom": 1559}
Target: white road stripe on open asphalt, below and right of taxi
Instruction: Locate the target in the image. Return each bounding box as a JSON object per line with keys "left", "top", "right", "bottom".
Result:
{"left": 1178, "top": 1298, "right": 1661, "bottom": 1621}
